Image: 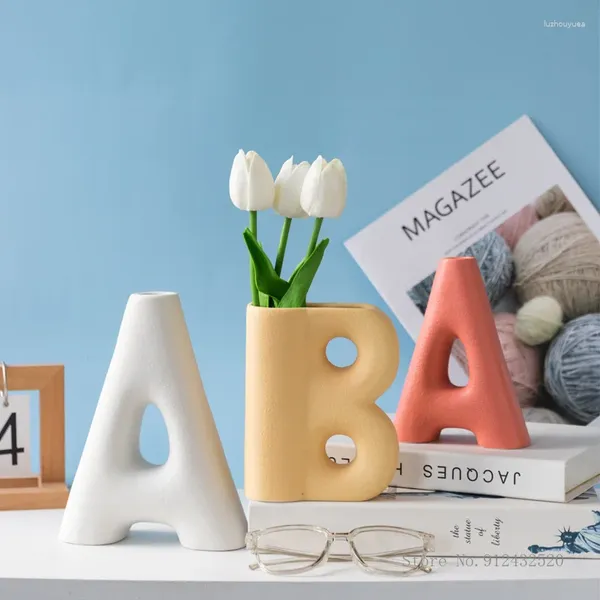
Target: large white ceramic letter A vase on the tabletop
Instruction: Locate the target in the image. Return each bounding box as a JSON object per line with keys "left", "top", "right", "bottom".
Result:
{"left": 59, "top": 293, "right": 247, "bottom": 550}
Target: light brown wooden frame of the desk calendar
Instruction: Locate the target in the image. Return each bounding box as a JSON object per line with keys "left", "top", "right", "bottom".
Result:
{"left": 0, "top": 365, "right": 69, "bottom": 510}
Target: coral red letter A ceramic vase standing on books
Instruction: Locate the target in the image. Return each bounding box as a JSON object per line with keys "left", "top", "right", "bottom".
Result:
{"left": 395, "top": 258, "right": 530, "bottom": 449}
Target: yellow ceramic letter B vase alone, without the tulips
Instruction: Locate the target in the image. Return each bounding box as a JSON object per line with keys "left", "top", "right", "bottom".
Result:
{"left": 245, "top": 305, "right": 399, "bottom": 502}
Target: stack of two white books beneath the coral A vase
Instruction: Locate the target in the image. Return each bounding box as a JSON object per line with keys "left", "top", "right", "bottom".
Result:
{"left": 249, "top": 423, "right": 600, "bottom": 559}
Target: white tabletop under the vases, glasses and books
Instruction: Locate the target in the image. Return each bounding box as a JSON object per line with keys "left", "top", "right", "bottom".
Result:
{"left": 0, "top": 510, "right": 600, "bottom": 600}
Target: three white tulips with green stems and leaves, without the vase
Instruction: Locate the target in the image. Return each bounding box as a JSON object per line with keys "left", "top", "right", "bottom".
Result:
{"left": 229, "top": 150, "right": 347, "bottom": 308}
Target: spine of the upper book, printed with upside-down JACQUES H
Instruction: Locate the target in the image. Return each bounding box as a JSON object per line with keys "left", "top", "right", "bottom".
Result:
{"left": 327, "top": 440, "right": 566, "bottom": 502}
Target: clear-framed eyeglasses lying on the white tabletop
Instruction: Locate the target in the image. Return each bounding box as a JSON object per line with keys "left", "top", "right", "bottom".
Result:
{"left": 246, "top": 525, "right": 435, "bottom": 576}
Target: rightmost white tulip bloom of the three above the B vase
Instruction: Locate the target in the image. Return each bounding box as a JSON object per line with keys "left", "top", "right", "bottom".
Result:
{"left": 300, "top": 156, "right": 348, "bottom": 219}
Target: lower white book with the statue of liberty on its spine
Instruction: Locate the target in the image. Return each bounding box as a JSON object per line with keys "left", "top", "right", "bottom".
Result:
{"left": 248, "top": 490, "right": 600, "bottom": 566}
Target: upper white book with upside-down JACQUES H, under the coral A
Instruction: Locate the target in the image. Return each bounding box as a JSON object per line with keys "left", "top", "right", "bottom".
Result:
{"left": 327, "top": 423, "right": 600, "bottom": 502}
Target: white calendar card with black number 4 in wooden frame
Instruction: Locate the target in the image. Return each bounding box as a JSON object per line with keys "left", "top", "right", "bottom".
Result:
{"left": 0, "top": 394, "right": 31, "bottom": 477}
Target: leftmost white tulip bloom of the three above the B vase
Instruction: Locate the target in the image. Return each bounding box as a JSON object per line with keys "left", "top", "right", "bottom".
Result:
{"left": 229, "top": 150, "right": 275, "bottom": 211}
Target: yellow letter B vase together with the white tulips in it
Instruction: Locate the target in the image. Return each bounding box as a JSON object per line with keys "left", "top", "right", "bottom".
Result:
{"left": 229, "top": 150, "right": 399, "bottom": 502}
